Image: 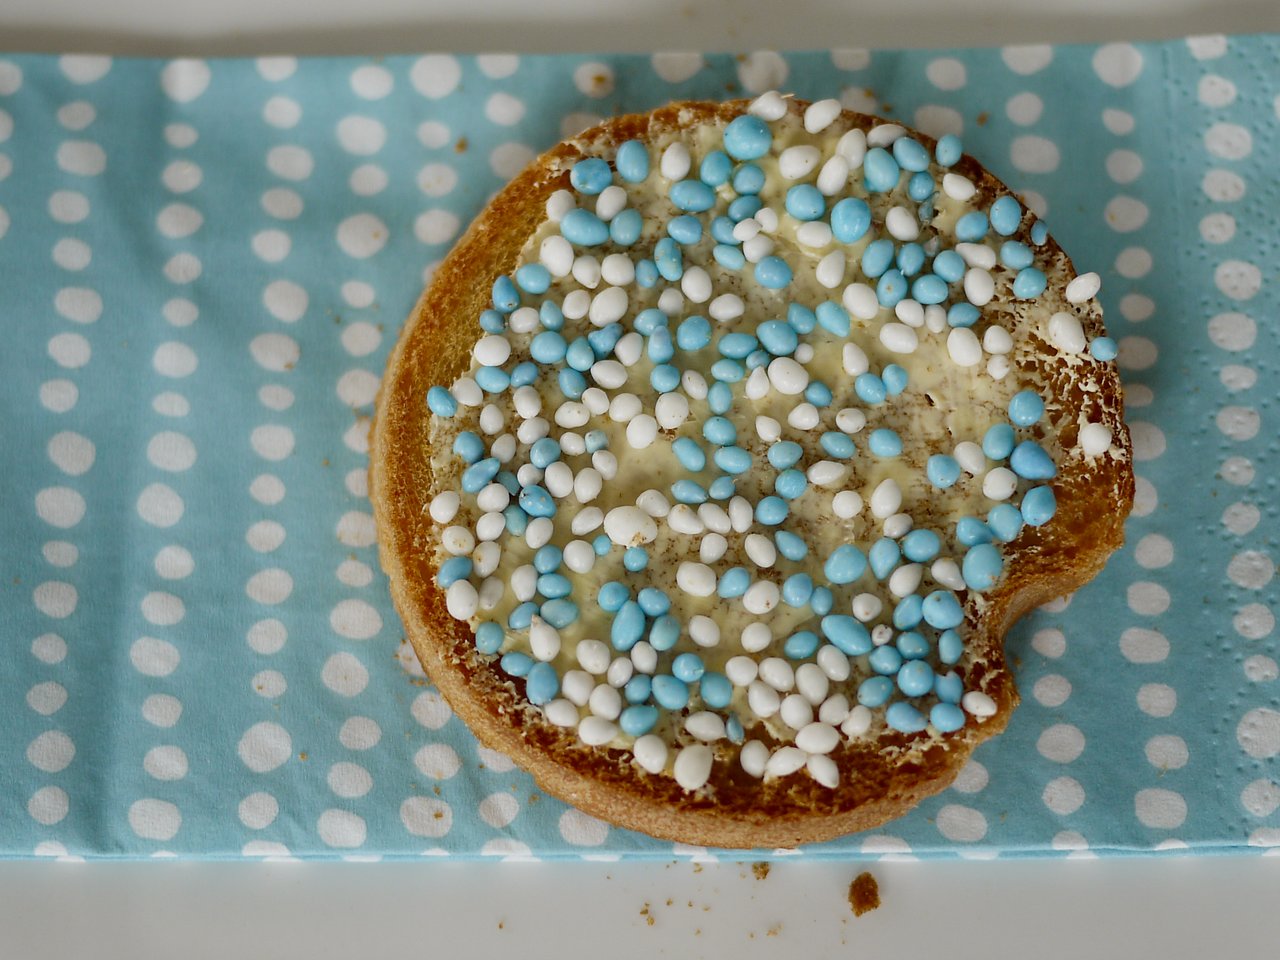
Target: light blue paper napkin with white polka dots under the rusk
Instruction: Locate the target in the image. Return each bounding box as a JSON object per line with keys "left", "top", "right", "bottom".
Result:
{"left": 0, "top": 36, "right": 1280, "bottom": 858}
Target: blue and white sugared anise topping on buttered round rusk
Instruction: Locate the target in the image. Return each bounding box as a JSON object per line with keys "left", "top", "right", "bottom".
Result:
{"left": 422, "top": 92, "right": 1115, "bottom": 790}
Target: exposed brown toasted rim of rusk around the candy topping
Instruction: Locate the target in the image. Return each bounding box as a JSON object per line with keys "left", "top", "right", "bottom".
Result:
{"left": 370, "top": 101, "right": 1134, "bottom": 847}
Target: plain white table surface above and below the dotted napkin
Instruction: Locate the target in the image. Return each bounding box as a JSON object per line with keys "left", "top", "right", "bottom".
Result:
{"left": 0, "top": 0, "right": 1280, "bottom": 960}
